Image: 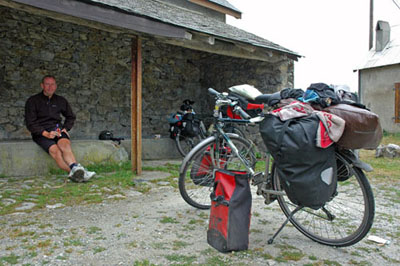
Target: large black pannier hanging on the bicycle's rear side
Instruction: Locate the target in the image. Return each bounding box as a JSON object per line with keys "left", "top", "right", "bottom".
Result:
{"left": 260, "top": 114, "right": 337, "bottom": 210}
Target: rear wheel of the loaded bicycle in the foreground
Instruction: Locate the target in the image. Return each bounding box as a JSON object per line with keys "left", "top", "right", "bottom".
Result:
{"left": 272, "top": 153, "right": 375, "bottom": 247}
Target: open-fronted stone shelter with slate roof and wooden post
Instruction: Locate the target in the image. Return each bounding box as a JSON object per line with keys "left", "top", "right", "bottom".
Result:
{"left": 0, "top": 0, "right": 299, "bottom": 175}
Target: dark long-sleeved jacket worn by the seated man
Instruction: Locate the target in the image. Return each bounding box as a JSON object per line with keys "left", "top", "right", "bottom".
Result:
{"left": 25, "top": 91, "right": 76, "bottom": 135}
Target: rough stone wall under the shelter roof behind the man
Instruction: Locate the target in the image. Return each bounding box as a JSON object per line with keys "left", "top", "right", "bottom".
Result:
{"left": 0, "top": 7, "right": 293, "bottom": 144}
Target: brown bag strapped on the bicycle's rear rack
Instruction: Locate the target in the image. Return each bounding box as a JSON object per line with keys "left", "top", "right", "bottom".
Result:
{"left": 323, "top": 104, "right": 383, "bottom": 150}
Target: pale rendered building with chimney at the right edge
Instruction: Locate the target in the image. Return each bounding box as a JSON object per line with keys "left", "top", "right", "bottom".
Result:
{"left": 358, "top": 21, "right": 400, "bottom": 133}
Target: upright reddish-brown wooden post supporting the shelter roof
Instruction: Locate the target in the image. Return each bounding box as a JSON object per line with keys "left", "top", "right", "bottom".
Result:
{"left": 131, "top": 37, "right": 142, "bottom": 175}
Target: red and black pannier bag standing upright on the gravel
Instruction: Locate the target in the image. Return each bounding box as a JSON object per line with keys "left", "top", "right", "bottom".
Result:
{"left": 207, "top": 170, "right": 251, "bottom": 252}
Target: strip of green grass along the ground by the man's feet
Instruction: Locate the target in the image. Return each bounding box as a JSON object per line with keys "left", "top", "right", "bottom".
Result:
{"left": 0, "top": 161, "right": 180, "bottom": 214}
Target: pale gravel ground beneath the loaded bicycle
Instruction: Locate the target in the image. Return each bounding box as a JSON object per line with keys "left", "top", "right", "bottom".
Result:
{"left": 0, "top": 161, "right": 400, "bottom": 265}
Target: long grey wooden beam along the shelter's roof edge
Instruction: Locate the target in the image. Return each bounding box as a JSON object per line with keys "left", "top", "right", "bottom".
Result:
{"left": 0, "top": 0, "right": 187, "bottom": 38}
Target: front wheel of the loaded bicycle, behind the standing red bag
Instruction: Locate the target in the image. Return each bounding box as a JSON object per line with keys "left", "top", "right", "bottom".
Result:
{"left": 178, "top": 134, "right": 256, "bottom": 209}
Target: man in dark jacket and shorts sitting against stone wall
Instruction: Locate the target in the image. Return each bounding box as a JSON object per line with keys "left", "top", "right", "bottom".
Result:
{"left": 25, "top": 75, "right": 96, "bottom": 183}
